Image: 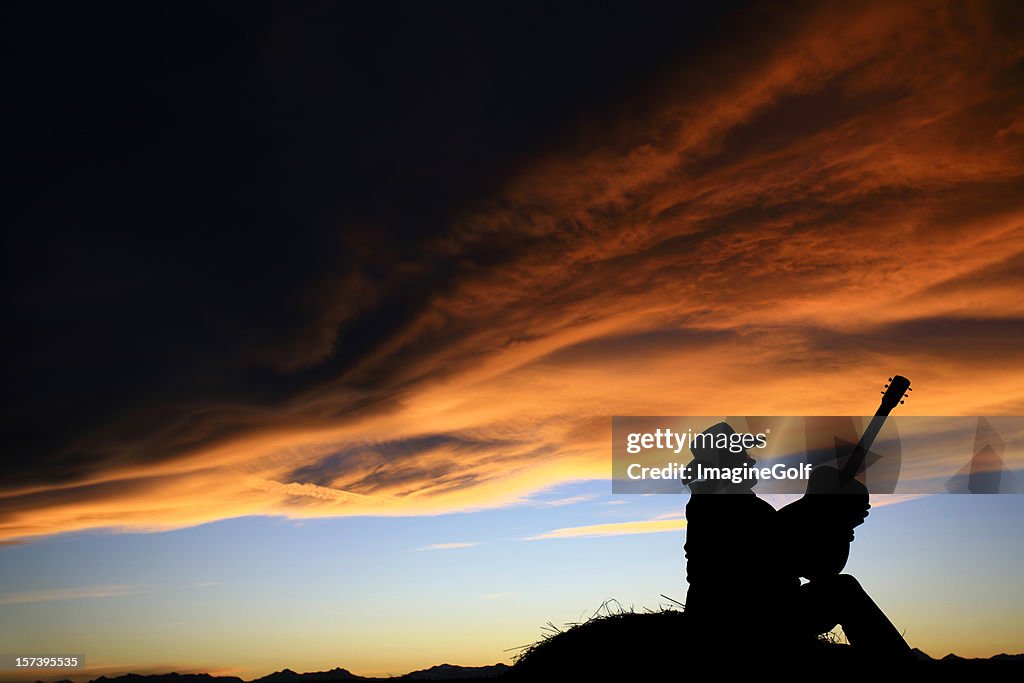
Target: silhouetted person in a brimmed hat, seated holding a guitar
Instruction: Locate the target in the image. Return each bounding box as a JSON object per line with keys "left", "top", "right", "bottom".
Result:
{"left": 684, "top": 422, "right": 913, "bottom": 661}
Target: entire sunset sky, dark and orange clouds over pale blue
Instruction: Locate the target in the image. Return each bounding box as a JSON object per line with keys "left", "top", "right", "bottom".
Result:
{"left": 0, "top": 2, "right": 1024, "bottom": 678}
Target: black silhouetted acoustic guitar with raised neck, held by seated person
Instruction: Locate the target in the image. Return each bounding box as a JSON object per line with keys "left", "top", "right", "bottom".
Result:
{"left": 777, "top": 375, "right": 910, "bottom": 581}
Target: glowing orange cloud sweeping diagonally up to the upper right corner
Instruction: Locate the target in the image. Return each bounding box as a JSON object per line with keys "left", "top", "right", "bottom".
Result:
{"left": 0, "top": 3, "right": 1024, "bottom": 541}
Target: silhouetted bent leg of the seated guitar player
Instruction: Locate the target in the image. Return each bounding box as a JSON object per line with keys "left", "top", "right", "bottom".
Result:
{"left": 800, "top": 574, "right": 913, "bottom": 661}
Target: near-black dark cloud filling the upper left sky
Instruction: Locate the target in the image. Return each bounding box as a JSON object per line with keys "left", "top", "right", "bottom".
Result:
{"left": 3, "top": 2, "right": 753, "bottom": 486}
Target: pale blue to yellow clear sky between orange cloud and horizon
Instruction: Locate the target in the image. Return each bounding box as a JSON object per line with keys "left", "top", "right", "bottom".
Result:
{"left": 0, "top": 480, "right": 1024, "bottom": 677}
